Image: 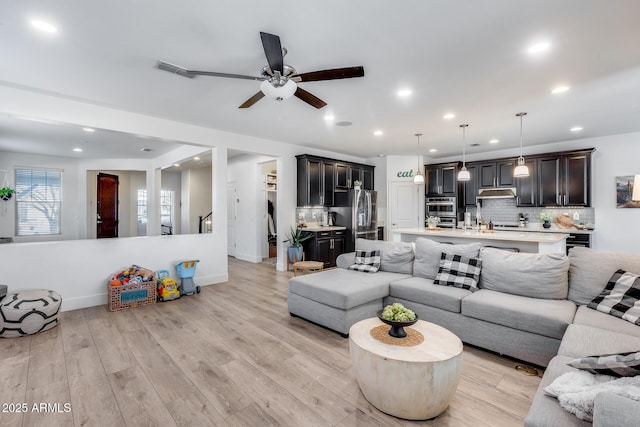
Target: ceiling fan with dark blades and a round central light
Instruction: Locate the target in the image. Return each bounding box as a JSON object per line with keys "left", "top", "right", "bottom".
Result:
{"left": 156, "top": 32, "right": 364, "bottom": 109}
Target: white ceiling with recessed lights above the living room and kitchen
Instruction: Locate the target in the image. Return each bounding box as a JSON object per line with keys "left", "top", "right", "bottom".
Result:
{"left": 0, "top": 0, "right": 640, "bottom": 157}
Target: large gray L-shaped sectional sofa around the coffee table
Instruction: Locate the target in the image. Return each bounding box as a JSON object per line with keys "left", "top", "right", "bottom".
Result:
{"left": 288, "top": 238, "right": 640, "bottom": 426}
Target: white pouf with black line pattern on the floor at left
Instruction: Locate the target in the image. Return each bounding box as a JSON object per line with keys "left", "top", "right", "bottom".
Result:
{"left": 0, "top": 289, "right": 62, "bottom": 338}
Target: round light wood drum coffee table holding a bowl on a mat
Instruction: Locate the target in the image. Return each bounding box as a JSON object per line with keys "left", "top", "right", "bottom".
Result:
{"left": 349, "top": 318, "right": 462, "bottom": 420}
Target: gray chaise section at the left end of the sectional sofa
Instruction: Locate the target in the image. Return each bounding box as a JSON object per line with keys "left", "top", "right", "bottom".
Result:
{"left": 288, "top": 268, "right": 402, "bottom": 337}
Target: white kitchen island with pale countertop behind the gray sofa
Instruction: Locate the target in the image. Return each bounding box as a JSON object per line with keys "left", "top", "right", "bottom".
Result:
{"left": 392, "top": 227, "right": 569, "bottom": 254}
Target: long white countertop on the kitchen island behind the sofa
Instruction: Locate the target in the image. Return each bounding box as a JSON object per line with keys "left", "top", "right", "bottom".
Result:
{"left": 393, "top": 227, "right": 569, "bottom": 243}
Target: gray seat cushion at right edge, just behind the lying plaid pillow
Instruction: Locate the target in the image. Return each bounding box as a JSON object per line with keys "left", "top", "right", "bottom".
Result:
{"left": 558, "top": 324, "right": 640, "bottom": 359}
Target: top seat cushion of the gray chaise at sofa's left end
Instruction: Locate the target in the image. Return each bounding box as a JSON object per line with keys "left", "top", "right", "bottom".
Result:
{"left": 289, "top": 268, "right": 410, "bottom": 310}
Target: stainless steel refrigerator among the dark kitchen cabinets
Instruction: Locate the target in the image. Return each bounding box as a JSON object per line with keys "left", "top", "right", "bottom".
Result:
{"left": 330, "top": 190, "right": 378, "bottom": 252}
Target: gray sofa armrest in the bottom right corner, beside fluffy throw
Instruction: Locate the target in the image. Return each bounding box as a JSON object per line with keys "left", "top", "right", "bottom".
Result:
{"left": 593, "top": 392, "right": 640, "bottom": 427}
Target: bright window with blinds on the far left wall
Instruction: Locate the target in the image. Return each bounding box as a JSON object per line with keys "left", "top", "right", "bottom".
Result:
{"left": 16, "top": 169, "right": 62, "bottom": 236}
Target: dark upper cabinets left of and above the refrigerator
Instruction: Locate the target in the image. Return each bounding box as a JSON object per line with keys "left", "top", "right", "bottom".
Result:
{"left": 296, "top": 154, "right": 375, "bottom": 207}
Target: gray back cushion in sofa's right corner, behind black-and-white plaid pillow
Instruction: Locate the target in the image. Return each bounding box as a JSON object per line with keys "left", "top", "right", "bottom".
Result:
{"left": 569, "top": 247, "right": 640, "bottom": 305}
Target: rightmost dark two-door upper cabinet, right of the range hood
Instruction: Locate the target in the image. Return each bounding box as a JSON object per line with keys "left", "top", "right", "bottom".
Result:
{"left": 538, "top": 151, "right": 591, "bottom": 207}
